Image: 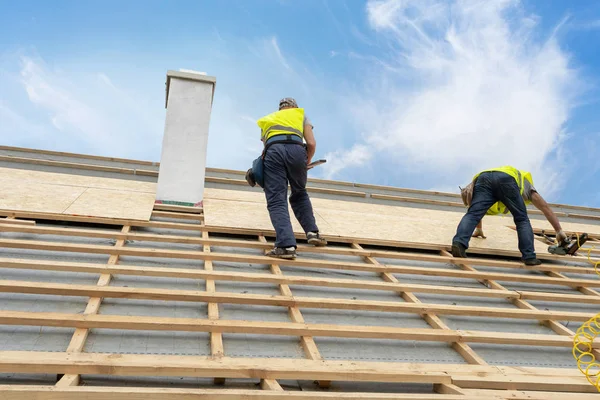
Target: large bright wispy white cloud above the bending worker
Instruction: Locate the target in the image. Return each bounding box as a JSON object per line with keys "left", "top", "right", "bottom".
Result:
{"left": 326, "top": 0, "right": 578, "bottom": 197}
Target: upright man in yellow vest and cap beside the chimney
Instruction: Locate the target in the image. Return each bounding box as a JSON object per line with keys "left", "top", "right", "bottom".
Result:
{"left": 257, "top": 97, "right": 327, "bottom": 259}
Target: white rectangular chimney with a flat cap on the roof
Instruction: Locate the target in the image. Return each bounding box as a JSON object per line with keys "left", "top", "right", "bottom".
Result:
{"left": 156, "top": 70, "right": 217, "bottom": 206}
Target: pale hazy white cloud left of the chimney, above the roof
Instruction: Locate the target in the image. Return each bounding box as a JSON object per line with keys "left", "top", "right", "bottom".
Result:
{"left": 8, "top": 56, "right": 164, "bottom": 158}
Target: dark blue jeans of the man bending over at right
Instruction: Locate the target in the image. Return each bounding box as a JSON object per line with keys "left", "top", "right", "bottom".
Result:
{"left": 452, "top": 171, "right": 536, "bottom": 260}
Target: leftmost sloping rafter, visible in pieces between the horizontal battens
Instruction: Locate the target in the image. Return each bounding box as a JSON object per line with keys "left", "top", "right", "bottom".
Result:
{"left": 56, "top": 225, "right": 131, "bottom": 386}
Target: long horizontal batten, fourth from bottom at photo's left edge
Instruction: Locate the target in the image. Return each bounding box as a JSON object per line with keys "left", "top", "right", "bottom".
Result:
{"left": 0, "top": 280, "right": 594, "bottom": 321}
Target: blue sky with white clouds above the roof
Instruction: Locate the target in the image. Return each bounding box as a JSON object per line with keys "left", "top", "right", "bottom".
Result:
{"left": 0, "top": 0, "right": 600, "bottom": 206}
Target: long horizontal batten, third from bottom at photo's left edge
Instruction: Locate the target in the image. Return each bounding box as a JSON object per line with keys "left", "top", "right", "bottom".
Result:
{"left": 0, "top": 311, "right": 588, "bottom": 346}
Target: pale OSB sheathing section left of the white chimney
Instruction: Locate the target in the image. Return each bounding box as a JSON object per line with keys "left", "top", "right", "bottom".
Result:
{"left": 0, "top": 168, "right": 156, "bottom": 221}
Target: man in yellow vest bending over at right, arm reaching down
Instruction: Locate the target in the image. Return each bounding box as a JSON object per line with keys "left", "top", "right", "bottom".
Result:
{"left": 452, "top": 166, "right": 567, "bottom": 265}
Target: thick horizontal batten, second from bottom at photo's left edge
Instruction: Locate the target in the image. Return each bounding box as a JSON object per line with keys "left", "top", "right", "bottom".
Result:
{"left": 0, "top": 351, "right": 451, "bottom": 382}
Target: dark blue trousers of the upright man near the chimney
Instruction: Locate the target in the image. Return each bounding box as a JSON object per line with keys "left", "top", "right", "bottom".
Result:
{"left": 264, "top": 143, "right": 319, "bottom": 247}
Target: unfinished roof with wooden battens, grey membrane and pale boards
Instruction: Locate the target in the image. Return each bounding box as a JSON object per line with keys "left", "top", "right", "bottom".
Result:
{"left": 0, "top": 147, "right": 600, "bottom": 399}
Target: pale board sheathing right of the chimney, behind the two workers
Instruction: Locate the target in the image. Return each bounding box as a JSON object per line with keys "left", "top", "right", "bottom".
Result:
{"left": 204, "top": 189, "right": 600, "bottom": 252}
